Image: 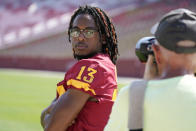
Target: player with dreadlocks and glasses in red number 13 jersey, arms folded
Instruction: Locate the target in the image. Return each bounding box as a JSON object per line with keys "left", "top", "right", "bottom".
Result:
{"left": 41, "top": 6, "right": 118, "bottom": 131}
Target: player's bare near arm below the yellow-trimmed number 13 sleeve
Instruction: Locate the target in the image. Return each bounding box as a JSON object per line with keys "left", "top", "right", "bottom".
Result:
{"left": 45, "top": 89, "right": 90, "bottom": 131}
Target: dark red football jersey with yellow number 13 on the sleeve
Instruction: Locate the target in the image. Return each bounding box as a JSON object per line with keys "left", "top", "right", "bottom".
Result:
{"left": 57, "top": 54, "right": 117, "bottom": 131}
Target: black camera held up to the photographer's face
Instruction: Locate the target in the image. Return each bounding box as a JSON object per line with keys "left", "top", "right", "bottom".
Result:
{"left": 135, "top": 36, "right": 155, "bottom": 63}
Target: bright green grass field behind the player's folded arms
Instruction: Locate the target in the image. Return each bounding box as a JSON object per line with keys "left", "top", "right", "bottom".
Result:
{"left": 0, "top": 69, "right": 128, "bottom": 131}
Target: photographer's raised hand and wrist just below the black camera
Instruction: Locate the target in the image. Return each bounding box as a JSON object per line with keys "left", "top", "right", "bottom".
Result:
{"left": 143, "top": 55, "right": 159, "bottom": 80}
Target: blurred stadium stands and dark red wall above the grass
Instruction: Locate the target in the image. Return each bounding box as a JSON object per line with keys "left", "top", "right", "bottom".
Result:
{"left": 0, "top": 0, "right": 196, "bottom": 78}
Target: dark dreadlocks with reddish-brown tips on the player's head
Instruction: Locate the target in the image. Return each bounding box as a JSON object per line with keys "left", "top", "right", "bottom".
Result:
{"left": 68, "top": 6, "right": 118, "bottom": 64}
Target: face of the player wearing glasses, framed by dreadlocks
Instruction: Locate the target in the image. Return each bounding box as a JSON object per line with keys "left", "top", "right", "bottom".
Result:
{"left": 70, "top": 14, "right": 102, "bottom": 56}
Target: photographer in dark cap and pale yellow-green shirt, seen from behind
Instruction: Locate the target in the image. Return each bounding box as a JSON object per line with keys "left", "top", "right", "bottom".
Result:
{"left": 105, "top": 9, "right": 196, "bottom": 131}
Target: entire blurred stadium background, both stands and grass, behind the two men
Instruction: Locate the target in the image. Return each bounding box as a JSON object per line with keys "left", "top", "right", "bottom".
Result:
{"left": 0, "top": 0, "right": 196, "bottom": 131}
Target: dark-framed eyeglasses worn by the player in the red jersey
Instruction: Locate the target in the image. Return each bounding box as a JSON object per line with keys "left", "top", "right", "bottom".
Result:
{"left": 70, "top": 28, "right": 98, "bottom": 38}
